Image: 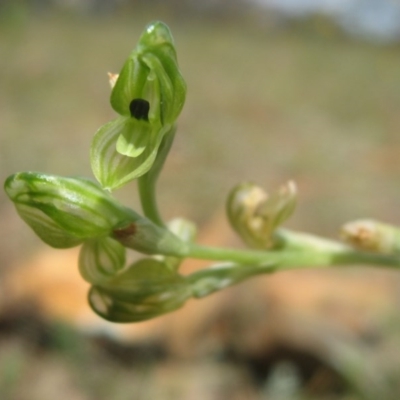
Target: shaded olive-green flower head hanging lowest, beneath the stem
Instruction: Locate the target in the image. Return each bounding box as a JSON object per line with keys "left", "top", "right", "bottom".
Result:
{"left": 89, "top": 259, "right": 191, "bottom": 322}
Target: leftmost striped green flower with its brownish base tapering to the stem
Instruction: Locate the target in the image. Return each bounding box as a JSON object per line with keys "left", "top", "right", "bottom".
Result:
{"left": 4, "top": 172, "right": 187, "bottom": 256}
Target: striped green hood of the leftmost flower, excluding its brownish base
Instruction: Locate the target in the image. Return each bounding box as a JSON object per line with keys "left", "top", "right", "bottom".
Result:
{"left": 5, "top": 172, "right": 132, "bottom": 248}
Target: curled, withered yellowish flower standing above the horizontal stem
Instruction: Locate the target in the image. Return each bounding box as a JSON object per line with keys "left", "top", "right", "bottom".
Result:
{"left": 227, "top": 182, "right": 297, "bottom": 249}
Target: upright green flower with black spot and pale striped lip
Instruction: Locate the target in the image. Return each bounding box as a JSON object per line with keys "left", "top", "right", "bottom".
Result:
{"left": 91, "top": 21, "right": 186, "bottom": 190}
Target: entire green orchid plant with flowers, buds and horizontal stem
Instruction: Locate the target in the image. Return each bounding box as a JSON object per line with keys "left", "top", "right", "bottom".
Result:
{"left": 5, "top": 22, "right": 400, "bottom": 322}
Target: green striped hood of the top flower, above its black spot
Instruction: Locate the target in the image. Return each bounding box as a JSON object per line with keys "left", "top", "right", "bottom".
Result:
{"left": 110, "top": 21, "right": 186, "bottom": 125}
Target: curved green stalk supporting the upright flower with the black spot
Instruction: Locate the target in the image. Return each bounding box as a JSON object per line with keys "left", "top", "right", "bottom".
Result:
{"left": 138, "top": 126, "right": 176, "bottom": 226}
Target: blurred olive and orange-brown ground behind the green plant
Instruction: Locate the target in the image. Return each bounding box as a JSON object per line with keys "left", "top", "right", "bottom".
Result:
{"left": 0, "top": 0, "right": 400, "bottom": 400}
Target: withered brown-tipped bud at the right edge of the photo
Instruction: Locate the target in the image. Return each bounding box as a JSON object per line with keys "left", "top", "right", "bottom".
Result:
{"left": 340, "top": 219, "right": 400, "bottom": 255}
